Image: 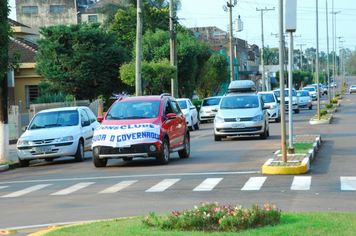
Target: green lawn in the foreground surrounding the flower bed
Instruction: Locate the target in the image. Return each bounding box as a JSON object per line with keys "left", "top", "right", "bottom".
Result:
{"left": 45, "top": 212, "right": 356, "bottom": 236}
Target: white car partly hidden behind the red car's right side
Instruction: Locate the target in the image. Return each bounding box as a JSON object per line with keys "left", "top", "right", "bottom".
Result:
{"left": 177, "top": 98, "right": 199, "bottom": 131}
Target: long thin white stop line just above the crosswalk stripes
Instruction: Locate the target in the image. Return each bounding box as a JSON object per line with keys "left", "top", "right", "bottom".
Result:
{"left": 0, "top": 170, "right": 261, "bottom": 184}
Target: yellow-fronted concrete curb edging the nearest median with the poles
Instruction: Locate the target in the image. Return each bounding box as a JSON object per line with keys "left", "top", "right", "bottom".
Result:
{"left": 262, "top": 135, "right": 321, "bottom": 175}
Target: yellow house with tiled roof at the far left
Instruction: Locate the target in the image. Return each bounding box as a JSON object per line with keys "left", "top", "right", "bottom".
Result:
{"left": 8, "top": 19, "right": 44, "bottom": 113}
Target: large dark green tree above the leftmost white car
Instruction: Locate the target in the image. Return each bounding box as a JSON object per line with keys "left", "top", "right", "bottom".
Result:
{"left": 36, "top": 23, "right": 128, "bottom": 99}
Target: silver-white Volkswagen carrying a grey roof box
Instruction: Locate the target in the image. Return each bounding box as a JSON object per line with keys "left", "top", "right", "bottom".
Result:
{"left": 214, "top": 80, "right": 270, "bottom": 141}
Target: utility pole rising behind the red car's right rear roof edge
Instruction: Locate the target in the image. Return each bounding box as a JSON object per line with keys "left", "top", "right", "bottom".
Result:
{"left": 169, "top": 0, "right": 178, "bottom": 98}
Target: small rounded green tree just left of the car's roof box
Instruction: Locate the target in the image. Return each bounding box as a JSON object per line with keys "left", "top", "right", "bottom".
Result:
{"left": 197, "top": 53, "right": 230, "bottom": 98}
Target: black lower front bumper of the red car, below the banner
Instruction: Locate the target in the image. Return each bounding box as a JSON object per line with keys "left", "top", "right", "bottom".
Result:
{"left": 92, "top": 142, "right": 161, "bottom": 159}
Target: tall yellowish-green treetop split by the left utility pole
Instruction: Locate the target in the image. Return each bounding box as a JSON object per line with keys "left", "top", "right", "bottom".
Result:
{"left": 110, "top": 3, "right": 169, "bottom": 54}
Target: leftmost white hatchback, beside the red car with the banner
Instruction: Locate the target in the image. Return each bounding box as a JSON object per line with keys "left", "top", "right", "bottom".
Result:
{"left": 17, "top": 107, "right": 100, "bottom": 167}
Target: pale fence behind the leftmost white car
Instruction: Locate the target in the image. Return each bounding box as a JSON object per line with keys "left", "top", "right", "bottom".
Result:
{"left": 8, "top": 99, "right": 103, "bottom": 140}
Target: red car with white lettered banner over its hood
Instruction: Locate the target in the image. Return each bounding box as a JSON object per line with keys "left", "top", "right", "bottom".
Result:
{"left": 92, "top": 93, "right": 190, "bottom": 167}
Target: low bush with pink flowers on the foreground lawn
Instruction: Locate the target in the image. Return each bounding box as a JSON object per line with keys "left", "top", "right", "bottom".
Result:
{"left": 142, "top": 202, "right": 281, "bottom": 232}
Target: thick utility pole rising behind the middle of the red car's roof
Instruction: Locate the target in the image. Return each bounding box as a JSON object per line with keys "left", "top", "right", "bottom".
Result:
{"left": 135, "top": 0, "right": 142, "bottom": 96}
